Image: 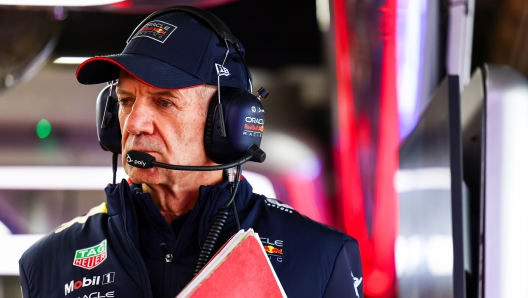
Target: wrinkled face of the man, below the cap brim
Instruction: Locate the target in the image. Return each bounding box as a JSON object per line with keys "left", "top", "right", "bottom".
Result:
{"left": 117, "top": 71, "right": 216, "bottom": 185}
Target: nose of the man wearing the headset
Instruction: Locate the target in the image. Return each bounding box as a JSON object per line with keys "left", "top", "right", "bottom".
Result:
{"left": 124, "top": 98, "right": 154, "bottom": 135}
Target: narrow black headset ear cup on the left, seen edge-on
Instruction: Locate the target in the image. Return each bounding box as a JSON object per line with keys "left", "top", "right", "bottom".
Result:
{"left": 95, "top": 84, "right": 121, "bottom": 154}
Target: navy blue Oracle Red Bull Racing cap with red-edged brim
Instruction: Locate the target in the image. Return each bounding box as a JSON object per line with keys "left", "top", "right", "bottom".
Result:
{"left": 76, "top": 11, "right": 251, "bottom": 90}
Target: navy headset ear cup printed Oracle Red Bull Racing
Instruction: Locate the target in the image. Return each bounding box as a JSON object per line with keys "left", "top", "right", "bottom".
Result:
{"left": 204, "top": 87, "right": 265, "bottom": 164}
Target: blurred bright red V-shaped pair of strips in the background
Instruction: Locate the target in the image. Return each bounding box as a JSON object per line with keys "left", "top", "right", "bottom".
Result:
{"left": 333, "top": 0, "right": 399, "bottom": 297}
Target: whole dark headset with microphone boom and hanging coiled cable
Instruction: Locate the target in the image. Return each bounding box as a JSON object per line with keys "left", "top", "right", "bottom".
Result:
{"left": 96, "top": 6, "right": 268, "bottom": 274}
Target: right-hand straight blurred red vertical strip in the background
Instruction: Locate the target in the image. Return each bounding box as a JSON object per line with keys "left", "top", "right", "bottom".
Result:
{"left": 365, "top": 0, "right": 399, "bottom": 297}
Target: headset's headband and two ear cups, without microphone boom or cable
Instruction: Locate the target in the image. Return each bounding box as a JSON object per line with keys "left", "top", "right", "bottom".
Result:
{"left": 96, "top": 6, "right": 268, "bottom": 170}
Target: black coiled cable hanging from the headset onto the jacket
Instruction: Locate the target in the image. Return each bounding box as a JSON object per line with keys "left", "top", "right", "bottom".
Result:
{"left": 194, "top": 165, "right": 242, "bottom": 275}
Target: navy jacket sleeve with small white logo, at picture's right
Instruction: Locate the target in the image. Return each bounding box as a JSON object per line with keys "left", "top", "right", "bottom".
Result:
{"left": 323, "top": 239, "right": 363, "bottom": 298}
